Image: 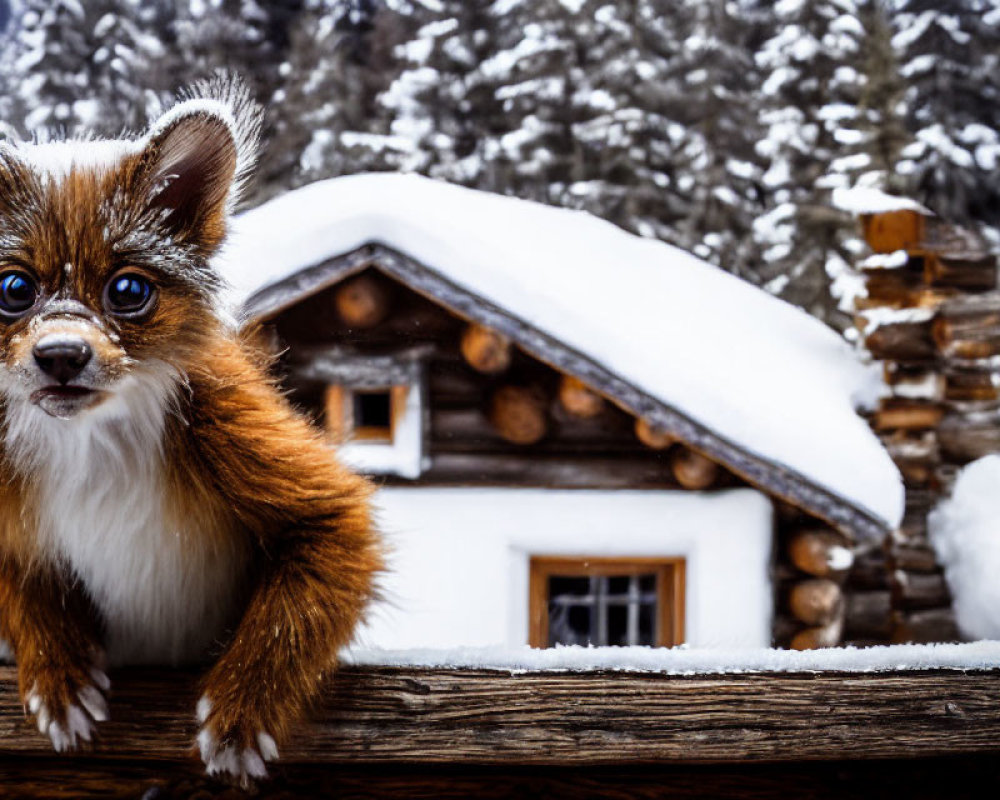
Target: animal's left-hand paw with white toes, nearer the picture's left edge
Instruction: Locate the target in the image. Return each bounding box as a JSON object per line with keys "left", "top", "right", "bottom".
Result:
{"left": 24, "top": 667, "right": 111, "bottom": 753}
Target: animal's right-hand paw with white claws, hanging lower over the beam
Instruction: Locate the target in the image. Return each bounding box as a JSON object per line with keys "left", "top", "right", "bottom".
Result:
{"left": 197, "top": 695, "right": 278, "bottom": 788}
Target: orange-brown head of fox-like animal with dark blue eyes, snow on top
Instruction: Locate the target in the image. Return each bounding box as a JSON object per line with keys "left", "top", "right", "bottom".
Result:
{"left": 0, "top": 81, "right": 259, "bottom": 421}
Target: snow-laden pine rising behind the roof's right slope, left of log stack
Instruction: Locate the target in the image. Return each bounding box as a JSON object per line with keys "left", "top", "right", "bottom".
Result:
{"left": 754, "top": 0, "right": 868, "bottom": 320}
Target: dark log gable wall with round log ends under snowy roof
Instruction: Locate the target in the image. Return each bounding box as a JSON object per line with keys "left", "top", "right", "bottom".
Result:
{"left": 272, "top": 270, "right": 742, "bottom": 489}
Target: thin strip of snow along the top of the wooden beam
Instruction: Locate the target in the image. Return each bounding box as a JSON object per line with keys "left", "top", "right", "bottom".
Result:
{"left": 344, "top": 641, "right": 1000, "bottom": 675}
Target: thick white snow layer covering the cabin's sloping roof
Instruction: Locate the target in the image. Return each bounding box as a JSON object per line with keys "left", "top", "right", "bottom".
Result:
{"left": 218, "top": 174, "right": 903, "bottom": 536}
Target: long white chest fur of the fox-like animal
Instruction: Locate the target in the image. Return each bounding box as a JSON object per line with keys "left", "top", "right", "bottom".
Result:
{"left": 8, "top": 372, "right": 246, "bottom": 665}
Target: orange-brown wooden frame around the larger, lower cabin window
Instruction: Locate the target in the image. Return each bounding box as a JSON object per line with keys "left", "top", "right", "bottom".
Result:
{"left": 528, "top": 556, "right": 687, "bottom": 648}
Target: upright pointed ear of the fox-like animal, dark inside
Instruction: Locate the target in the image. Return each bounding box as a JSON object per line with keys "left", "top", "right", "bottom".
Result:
{"left": 140, "top": 100, "right": 239, "bottom": 255}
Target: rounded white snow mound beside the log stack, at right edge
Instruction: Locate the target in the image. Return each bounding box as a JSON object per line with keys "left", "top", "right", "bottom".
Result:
{"left": 928, "top": 455, "right": 1000, "bottom": 639}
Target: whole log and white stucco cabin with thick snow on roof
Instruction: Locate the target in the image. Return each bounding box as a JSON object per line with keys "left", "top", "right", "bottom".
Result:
{"left": 222, "top": 174, "right": 903, "bottom": 649}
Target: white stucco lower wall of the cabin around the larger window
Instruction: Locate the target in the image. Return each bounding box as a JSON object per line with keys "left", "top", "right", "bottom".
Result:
{"left": 357, "top": 488, "right": 773, "bottom": 649}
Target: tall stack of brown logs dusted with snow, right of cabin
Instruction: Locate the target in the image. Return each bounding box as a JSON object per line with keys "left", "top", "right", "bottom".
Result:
{"left": 855, "top": 195, "right": 1000, "bottom": 641}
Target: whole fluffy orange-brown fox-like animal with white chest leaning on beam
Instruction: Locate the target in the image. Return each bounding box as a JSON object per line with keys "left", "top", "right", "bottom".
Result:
{"left": 0, "top": 81, "right": 382, "bottom": 782}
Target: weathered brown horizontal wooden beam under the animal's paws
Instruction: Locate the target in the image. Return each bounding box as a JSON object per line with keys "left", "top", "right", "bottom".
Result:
{"left": 0, "top": 667, "right": 1000, "bottom": 768}
